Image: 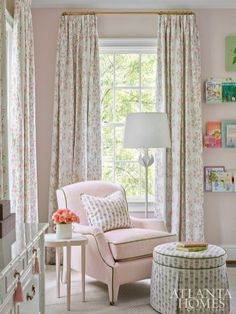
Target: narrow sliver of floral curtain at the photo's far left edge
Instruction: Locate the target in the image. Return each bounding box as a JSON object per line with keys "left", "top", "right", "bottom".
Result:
{"left": 0, "top": 0, "right": 9, "bottom": 199}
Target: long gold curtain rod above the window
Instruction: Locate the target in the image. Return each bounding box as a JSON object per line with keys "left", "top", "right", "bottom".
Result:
{"left": 62, "top": 11, "right": 195, "bottom": 16}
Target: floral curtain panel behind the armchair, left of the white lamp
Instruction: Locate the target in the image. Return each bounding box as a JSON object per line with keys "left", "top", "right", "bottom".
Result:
{"left": 49, "top": 15, "right": 101, "bottom": 221}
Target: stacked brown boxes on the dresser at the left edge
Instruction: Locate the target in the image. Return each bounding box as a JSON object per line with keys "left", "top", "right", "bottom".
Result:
{"left": 0, "top": 200, "right": 16, "bottom": 238}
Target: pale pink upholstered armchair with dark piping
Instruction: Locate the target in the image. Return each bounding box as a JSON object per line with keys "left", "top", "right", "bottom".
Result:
{"left": 57, "top": 181, "right": 176, "bottom": 304}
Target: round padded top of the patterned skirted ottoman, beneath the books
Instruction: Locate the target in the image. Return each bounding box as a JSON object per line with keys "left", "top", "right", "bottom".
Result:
{"left": 153, "top": 243, "right": 227, "bottom": 269}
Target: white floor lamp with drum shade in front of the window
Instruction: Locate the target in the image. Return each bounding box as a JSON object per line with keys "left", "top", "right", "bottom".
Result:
{"left": 124, "top": 112, "right": 171, "bottom": 218}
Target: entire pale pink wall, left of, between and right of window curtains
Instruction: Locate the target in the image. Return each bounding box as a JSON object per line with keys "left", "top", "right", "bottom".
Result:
{"left": 33, "top": 9, "right": 236, "bottom": 245}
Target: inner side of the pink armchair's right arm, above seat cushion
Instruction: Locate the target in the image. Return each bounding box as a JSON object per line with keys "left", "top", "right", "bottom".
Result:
{"left": 130, "top": 217, "right": 168, "bottom": 232}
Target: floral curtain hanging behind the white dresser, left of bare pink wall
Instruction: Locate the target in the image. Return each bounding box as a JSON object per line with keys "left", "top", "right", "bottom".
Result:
{"left": 10, "top": 0, "right": 38, "bottom": 223}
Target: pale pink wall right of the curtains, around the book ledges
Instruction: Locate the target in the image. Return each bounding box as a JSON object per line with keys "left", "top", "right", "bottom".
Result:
{"left": 198, "top": 10, "right": 236, "bottom": 248}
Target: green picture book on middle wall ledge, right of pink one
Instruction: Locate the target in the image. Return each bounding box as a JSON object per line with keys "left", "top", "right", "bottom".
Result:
{"left": 221, "top": 120, "right": 236, "bottom": 148}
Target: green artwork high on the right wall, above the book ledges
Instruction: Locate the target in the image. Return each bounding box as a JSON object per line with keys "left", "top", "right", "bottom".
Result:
{"left": 225, "top": 36, "right": 236, "bottom": 72}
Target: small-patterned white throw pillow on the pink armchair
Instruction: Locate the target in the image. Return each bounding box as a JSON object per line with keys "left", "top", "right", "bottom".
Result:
{"left": 81, "top": 191, "right": 131, "bottom": 231}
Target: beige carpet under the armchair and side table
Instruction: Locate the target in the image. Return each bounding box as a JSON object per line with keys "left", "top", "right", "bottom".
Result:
{"left": 46, "top": 266, "right": 236, "bottom": 314}
